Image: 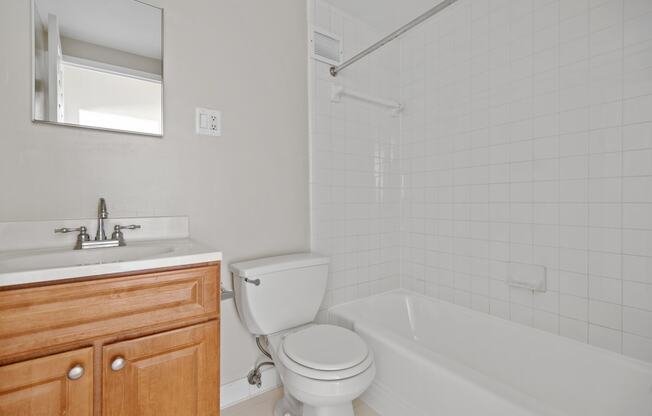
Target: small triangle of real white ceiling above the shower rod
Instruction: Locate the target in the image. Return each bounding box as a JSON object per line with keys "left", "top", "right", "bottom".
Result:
{"left": 325, "top": 0, "right": 441, "bottom": 33}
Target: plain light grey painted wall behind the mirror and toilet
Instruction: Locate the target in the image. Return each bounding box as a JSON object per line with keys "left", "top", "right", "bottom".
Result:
{"left": 0, "top": 0, "right": 309, "bottom": 382}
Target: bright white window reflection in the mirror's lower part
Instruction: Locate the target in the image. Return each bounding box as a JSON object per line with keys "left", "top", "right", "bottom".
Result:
{"left": 63, "top": 60, "right": 161, "bottom": 134}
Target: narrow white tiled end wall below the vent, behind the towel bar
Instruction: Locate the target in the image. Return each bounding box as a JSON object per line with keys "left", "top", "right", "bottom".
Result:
{"left": 310, "top": 0, "right": 400, "bottom": 308}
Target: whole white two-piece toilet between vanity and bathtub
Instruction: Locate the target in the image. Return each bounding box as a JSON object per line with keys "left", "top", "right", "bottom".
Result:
{"left": 231, "top": 253, "right": 376, "bottom": 416}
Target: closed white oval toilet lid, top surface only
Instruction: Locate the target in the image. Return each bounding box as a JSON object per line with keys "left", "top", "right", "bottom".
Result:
{"left": 283, "top": 325, "right": 369, "bottom": 371}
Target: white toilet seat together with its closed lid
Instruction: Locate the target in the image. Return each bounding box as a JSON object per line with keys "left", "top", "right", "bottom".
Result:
{"left": 278, "top": 325, "right": 373, "bottom": 380}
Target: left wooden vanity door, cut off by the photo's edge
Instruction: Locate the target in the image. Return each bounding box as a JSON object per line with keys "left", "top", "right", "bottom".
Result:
{"left": 0, "top": 348, "right": 93, "bottom": 416}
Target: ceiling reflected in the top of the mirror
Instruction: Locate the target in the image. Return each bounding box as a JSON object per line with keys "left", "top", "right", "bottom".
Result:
{"left": 35, "top": 0, "right": 162, "bottom": 59}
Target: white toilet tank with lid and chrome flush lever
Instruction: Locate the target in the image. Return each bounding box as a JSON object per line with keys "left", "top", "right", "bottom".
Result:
{"left": 230, "top": 253, "right": 329, "bottom": 335}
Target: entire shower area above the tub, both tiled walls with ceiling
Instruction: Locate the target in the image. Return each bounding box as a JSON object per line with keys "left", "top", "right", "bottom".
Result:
{"left": 308, "top": 0, "right": 652, "bottom": 363}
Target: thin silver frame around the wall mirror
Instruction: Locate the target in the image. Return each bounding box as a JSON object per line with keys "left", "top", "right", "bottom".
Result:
{"left": 30, "top": 0, "right": 165, "bottom": 139}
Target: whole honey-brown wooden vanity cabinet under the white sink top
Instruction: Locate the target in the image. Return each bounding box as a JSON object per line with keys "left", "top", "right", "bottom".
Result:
{"left": 0, "top": 263, "right": 220, "bottom": 416}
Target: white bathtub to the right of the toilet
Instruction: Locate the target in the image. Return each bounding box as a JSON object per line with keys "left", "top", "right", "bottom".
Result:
{"left": 329, "top": 290, "right": 652, "bottom": 416}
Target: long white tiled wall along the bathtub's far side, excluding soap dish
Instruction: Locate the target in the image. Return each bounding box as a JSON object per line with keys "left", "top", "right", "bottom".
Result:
{"left": 401, "top": 0, "right": 652, "bottom": 361}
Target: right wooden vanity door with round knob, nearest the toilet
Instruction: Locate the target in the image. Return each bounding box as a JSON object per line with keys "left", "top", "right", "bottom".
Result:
{"left": 102, "top": 321, "right": 220, "bottom": 416}
